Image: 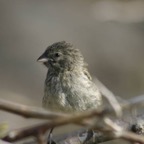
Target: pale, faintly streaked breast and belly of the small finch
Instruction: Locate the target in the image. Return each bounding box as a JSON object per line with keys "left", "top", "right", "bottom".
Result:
{"left": 43, "top": 73, "right": 101, "bottom": 112}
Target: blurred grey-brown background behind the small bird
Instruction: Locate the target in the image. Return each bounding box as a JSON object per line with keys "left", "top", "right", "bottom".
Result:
{"left": 0, "top": 0, "right": 144, "bottom": 143}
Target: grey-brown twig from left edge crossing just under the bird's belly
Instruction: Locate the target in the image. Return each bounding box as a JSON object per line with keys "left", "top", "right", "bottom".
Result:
{"left": 0, "top": 99, "right": 110, "bottom": 122}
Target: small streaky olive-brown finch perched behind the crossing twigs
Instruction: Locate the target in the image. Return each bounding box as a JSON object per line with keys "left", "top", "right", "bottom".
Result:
{"left": 38, "top": 41, "right": 102, "bottom": 113}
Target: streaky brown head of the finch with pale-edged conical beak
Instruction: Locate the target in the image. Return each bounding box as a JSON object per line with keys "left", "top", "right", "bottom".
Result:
{"left": 37, "top": 41, "right": 84, "bottom": 70}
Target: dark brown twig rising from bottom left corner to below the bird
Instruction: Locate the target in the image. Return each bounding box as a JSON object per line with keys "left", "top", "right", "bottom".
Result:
{"left": 1, "top": 110, "right": 105, "bottom": 142}
